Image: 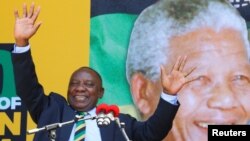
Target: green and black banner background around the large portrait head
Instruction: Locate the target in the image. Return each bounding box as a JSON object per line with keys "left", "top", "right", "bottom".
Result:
{"left": 90, "top": 0, "right": 250, "bottom": 141}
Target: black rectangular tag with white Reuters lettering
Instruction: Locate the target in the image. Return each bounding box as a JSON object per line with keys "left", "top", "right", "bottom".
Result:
{"left": 208, "top": 125, "right": 250, "bottom": 141}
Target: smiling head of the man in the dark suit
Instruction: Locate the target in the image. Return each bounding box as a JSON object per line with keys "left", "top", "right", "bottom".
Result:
{"left": 68, "top": 67, "right": 104, "bottom": 111}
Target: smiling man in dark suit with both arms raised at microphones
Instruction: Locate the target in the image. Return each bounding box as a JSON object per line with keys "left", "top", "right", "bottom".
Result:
{"left": 12, "top": 4, "right": 192, "bottom": 141}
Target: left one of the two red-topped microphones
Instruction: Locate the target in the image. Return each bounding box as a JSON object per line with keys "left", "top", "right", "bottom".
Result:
{"left": 96, "top": 103, "right": 109, "bottom": 126}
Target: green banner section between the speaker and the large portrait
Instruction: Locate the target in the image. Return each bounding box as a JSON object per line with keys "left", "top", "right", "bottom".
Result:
{"left": 90, "top": 14, "right": 137, "bottom": 105}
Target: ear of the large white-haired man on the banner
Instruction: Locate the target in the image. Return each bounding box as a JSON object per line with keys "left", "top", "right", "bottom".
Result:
{"left": 130, "top": 73, "right": 151, "bottom": 115}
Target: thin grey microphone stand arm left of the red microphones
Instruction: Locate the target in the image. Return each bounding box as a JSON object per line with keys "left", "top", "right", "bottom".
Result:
{"left": 27, "top": 116, "right": 96, "bottom": 141}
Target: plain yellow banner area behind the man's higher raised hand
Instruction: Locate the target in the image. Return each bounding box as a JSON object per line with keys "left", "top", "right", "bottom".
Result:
{"left": 0, "top": 0, "right": 90, "bottom": 140}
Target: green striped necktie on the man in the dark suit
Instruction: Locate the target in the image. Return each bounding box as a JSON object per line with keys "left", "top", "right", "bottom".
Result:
{"left": 74, "top": 112, "right": 86, "bottom": 141}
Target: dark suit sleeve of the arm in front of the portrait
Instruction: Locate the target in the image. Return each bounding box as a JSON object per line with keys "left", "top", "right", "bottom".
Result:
{"left": 121, "top": 99, "right": 179, "bottom": 141}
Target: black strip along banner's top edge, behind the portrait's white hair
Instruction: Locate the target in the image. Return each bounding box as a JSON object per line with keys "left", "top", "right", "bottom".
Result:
{"left": 91, "top": 0, "right": 250, "bottom": 21}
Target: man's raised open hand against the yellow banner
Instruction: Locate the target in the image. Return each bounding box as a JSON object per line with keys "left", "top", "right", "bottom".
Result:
{"left": 14, "top": 3, "right": 41, "bottom": 47}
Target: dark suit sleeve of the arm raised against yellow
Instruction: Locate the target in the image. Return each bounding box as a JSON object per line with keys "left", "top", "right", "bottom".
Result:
{"left": 12, "top": 50, "right": 48, "bottom": 123}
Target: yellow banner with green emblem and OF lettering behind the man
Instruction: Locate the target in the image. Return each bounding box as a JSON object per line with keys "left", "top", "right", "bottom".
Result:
{"left": 0, "top": 0, "right": 90, "bottom": 141}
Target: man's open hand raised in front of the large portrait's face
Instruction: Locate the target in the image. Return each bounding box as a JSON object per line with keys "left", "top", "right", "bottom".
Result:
{"left": 161, "top": 56, "right": 195, "bottom": 95}
